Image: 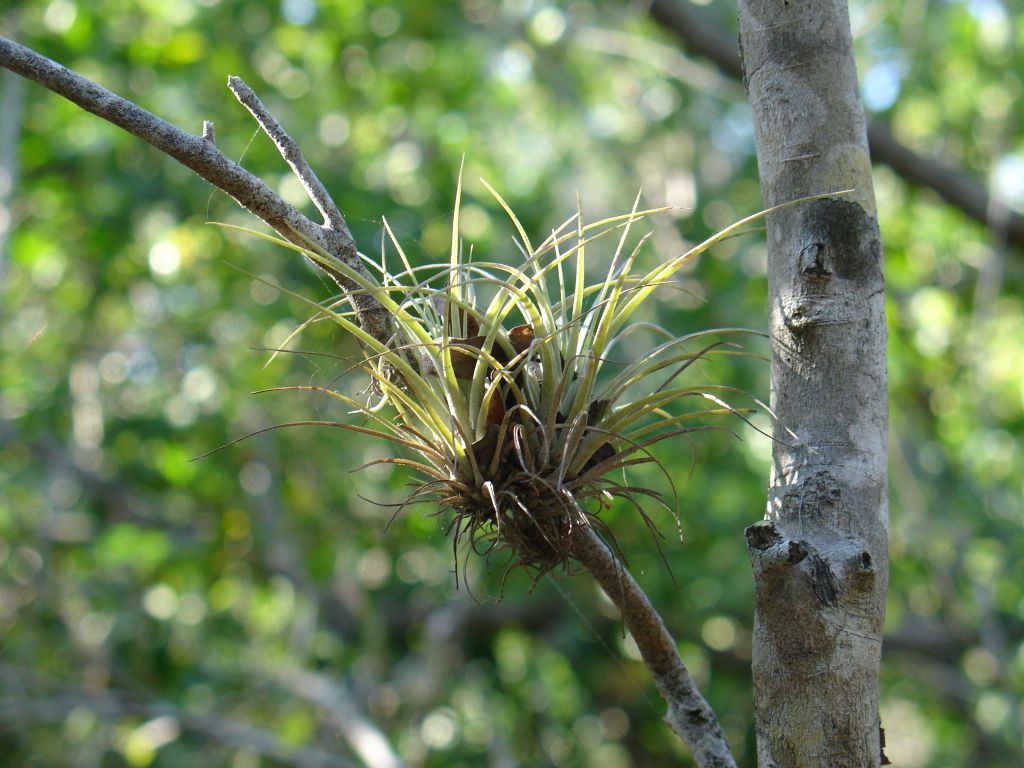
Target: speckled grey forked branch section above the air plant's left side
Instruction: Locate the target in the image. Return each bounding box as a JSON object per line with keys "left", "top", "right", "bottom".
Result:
{"left": 0, "top": 37, "right": 393, "bottom": 344}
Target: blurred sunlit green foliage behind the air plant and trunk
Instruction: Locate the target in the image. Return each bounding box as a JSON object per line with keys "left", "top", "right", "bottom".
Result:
{"left": 0, "top": 0, "right": 1024, "bottom": 768}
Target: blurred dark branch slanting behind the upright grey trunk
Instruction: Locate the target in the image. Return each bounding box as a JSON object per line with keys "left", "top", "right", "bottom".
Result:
{"left": 649, "top": 0, "right": 1024, "bottom": 248}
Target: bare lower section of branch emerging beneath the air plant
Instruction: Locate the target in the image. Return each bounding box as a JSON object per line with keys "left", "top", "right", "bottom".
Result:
{"left": 572, "top": 526, "right": 736, "bottom": 768}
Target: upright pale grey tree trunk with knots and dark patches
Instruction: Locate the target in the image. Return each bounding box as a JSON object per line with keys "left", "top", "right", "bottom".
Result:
{"left": 739, "top": 0, "right": 889, "bottom": 768}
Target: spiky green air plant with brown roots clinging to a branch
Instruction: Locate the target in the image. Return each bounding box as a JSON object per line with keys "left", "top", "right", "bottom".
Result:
{"left": 222, "top": 179, "right": 806, "bottom": 579}
